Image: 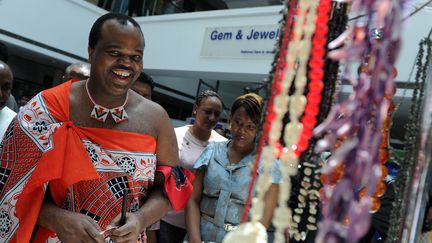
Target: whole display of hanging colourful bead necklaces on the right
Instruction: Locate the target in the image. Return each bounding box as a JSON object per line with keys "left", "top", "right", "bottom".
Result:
{"left": 224, "top": 0, "right": 432, "bottom": 240}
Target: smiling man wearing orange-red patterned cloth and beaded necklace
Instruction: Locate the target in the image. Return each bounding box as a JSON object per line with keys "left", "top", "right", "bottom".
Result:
{"left": 0, "top": 13, "right": 192, "bottom": 242}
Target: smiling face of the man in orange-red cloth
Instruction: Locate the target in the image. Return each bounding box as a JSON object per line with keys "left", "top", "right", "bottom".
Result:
{"left": 89, "top": 20, "right": 144, "bottom": 95}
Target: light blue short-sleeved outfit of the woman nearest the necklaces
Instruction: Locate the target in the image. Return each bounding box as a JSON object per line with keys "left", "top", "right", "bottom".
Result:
{"left": 194, "top": 141, "right": 281, "bottom": 242}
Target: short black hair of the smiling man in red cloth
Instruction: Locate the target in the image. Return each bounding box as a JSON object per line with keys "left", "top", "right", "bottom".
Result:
{"left": 89, "top": 13, "right": 144, "bottom": 49}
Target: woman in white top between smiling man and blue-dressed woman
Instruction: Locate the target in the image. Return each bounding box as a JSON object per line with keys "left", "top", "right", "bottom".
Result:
{"left": 157, "top": 90, "right": 227, "bottom": 243}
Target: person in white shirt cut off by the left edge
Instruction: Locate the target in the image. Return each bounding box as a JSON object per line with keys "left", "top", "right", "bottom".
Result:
{"left": 0, "top": 61, "right": 16, "bottom": 139}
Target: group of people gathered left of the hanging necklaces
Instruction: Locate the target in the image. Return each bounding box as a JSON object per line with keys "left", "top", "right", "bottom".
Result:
{"left": 0, "top": 13, "right": 281, "bottom": 243}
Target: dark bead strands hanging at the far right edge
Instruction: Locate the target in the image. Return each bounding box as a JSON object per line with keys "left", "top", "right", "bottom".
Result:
{"left": 386, "top": 36, "right": 432, "bottom": 243}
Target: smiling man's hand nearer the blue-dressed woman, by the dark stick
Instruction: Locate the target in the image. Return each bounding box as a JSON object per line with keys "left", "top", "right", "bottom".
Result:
{"left": 110, "top": 213, "right": 145, "bottom": 243}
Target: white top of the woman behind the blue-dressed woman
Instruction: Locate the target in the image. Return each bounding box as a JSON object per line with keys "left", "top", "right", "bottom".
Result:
{"left": 162, "top": 125, "right": 227, "bottom": 229}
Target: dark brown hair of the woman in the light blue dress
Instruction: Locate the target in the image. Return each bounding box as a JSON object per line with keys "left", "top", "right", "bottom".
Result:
{"left": 231, "top": 93, "right": 264, "bottom": 124}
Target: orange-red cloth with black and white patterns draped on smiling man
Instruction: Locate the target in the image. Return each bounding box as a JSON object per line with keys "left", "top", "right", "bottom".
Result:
{"left": 0, "top": 82, "right": 160, "bottom": 242}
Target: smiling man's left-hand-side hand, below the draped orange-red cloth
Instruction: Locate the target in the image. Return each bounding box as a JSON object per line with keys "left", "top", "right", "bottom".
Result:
{"left": 54, "top": 210, "right": 105, "bottom": 243}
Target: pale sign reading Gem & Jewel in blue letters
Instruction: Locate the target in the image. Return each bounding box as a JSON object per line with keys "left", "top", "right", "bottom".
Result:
{"left": 201, "top": 25, "right": 280, "bottom": 59}
